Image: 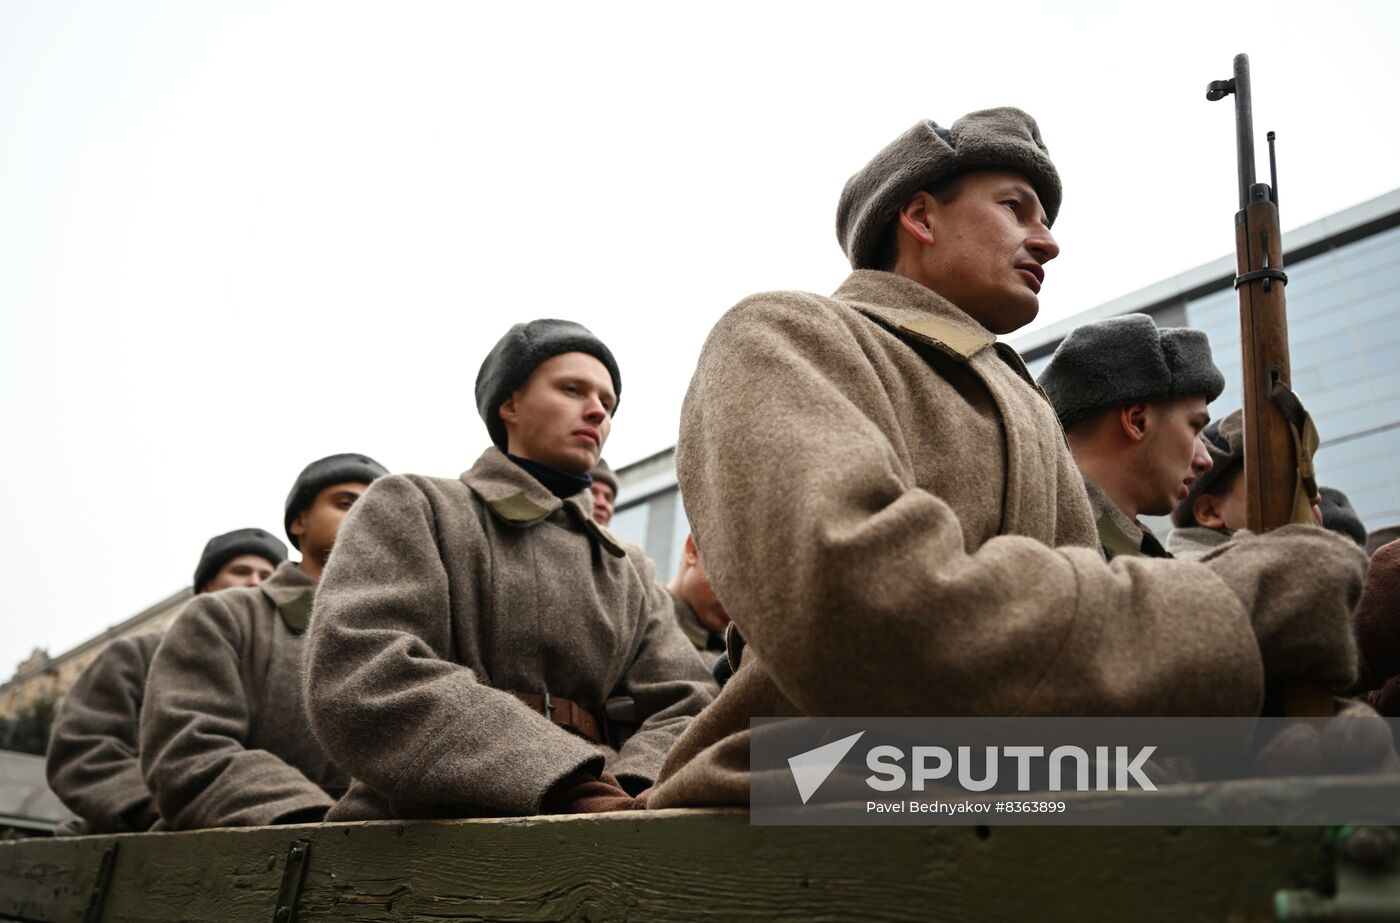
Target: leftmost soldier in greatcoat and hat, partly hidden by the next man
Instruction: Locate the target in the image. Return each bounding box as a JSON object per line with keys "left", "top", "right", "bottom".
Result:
{"left": 46, "top": 528, "right": 287, "bottom": 836}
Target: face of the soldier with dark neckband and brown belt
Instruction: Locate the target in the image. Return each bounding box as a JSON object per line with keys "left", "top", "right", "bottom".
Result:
{"left": 500, "top": 353, "right": 617, "bottom": 475}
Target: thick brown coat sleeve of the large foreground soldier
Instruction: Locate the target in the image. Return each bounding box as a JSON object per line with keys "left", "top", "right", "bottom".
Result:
{"left": 676, "top": 294, "right": 1263, "bottom": 716}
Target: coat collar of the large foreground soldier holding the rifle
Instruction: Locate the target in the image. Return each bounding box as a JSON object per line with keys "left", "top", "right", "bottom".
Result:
{"left": 832, "top": 269, "right": 997, "bottom": 361}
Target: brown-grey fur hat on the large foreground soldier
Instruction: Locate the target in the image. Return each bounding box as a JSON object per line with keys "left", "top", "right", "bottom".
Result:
{"left": 836, "top": 106, "right": 1061, "bottom": 269}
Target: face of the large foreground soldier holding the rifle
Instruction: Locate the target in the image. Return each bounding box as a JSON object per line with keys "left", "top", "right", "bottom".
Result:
{"left": 923, "top": 169, "right": 1060, "bottom": 333}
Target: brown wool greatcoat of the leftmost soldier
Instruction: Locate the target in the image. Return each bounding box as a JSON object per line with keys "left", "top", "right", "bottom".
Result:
{"left": 46, "top": 632, "right": 161, "bottom": 836}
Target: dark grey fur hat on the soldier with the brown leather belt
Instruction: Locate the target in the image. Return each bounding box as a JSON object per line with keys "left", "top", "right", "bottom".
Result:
{"left": 476, "top": 319, "right": 622, "bottom": 452}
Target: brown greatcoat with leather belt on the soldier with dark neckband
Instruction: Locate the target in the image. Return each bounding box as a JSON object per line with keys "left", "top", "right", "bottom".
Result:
{"left": 307, "top": 447, "right": 715, "bottom": 821}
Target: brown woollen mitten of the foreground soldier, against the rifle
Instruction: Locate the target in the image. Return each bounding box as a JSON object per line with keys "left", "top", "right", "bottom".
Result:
{"left": 1201, "top": 525, "right": 1366, "bottom": 690}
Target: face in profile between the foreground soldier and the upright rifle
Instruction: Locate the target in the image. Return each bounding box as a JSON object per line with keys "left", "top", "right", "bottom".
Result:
{"left": 1130, "top": 396, "right": 1211, "bottom": 515}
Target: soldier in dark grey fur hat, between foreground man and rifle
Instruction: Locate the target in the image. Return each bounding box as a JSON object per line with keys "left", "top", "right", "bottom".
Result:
{"left": 1039, "top": 314, "right": 1225, "bottom": 559}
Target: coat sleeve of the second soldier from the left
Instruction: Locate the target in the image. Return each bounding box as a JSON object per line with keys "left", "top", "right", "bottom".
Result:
{"left": 141, "top": 594, "right": 335, "bottom": 831}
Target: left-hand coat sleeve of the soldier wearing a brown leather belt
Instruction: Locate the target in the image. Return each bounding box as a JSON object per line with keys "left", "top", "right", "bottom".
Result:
{"left": 307, "top": 475, "right": 603, "bottom": 815}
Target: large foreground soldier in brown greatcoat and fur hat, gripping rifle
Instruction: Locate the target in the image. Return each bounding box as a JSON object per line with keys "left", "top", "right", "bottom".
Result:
{"left": 648, "top": 108, "right": 1365, "bottom": 808}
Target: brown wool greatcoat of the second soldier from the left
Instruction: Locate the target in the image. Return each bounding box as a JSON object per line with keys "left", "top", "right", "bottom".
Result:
{"left": 141, "top": 562, "right": 349, "bottom": 829}
